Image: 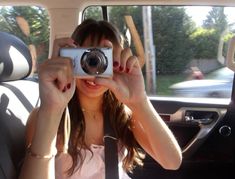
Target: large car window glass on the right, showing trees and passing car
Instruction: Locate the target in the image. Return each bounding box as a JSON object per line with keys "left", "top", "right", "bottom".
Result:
{"left": 84, "top": 6, "right": 235, "bottom": 98}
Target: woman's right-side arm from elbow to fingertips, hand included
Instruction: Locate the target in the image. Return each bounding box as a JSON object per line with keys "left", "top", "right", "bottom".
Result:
{"left": 95, "top": 42, "right": 182, "bottom": 169}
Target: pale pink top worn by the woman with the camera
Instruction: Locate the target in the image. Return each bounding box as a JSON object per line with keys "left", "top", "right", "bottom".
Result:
{"left": 55, "top": 144, "right": 131, "bottom": 179}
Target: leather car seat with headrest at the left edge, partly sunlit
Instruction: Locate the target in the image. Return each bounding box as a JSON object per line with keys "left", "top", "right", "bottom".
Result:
{"left": 0, "top": 32, "right": 39, "bottom": 179}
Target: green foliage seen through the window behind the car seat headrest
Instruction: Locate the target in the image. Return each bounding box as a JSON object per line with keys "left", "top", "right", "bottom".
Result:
{"left": 0, "top": 6, "right": 50, "bottom": 59}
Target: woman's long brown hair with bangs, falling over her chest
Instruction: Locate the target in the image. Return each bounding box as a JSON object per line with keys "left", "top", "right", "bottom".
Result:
{"left": 58, "top": 19, "right": 142, "bottom": 175}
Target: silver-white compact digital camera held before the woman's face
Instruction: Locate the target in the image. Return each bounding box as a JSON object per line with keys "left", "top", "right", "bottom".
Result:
{"left": 60, "top": 47, "right": 113, "bottom": 78}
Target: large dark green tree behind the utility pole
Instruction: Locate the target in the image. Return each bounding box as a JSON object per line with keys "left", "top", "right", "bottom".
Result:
{"left": 83, "top": 6, "right": 195, "bottom": 74}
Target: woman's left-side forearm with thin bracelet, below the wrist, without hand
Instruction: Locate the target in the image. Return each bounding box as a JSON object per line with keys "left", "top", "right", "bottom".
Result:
{"left": 20, "top": 109, "right": 61, "bottom": 179}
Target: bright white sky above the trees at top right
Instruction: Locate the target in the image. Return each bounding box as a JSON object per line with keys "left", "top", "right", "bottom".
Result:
{"left": 186, "top": 6, "right": 235, "bottom": 26}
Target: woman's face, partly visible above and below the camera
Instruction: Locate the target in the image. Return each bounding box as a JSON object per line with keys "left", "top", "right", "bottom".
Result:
{"left": 76, "top": 35, "right": 111, "bottom": 98}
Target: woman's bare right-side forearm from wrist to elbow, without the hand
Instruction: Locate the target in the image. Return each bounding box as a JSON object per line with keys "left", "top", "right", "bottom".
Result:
{"left": 129, "top": 96, "right": 182, "bottom": 170}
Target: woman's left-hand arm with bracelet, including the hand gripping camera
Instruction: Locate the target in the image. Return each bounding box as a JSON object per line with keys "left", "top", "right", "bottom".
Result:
{"left": 20, "top": 39, "right": 76, "bottom": 179}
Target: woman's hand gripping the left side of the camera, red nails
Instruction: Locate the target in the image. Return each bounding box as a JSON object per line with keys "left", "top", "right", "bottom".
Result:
{"left": 38, "top": 38, "right": 76, "bottom": 111}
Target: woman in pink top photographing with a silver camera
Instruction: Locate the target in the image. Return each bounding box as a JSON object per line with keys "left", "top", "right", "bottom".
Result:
{"left": 21, "top": 20, "right": 182, "bottom": 179}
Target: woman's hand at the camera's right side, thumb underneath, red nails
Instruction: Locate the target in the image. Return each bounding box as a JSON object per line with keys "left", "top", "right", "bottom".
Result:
{"left": 95, "top": 40, "right": 146, "bottom": 106}
